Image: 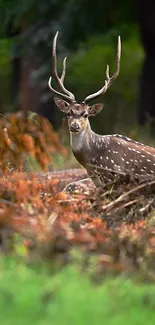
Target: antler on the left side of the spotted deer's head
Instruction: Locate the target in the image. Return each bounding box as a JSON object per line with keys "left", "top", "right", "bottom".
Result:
{"left": 50, "top": 31, "right": 75, "bottom": 101}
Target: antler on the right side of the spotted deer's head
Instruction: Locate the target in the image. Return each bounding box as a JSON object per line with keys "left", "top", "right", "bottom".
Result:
{"left": 83, "top": 36, "right": 121, "bottom": 103}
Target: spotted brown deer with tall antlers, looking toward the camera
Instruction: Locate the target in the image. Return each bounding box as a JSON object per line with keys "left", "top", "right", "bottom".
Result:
{"left": 48, "top": 32, "right": 155, "bottom": 186}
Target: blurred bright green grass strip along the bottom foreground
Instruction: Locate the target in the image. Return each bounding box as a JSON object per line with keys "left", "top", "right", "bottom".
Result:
{"left": 0, "top": 259, "right": 155, "bottom": 325}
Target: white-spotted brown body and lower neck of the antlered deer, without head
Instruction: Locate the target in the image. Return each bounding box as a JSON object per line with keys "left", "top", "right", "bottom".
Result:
{"left": 70, "top": 122, "right": 155, "bottom": 185}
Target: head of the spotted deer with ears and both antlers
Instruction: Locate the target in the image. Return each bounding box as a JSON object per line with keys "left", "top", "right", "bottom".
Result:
{"left": 48, "top": 32, "right": 121, "bottom": 133}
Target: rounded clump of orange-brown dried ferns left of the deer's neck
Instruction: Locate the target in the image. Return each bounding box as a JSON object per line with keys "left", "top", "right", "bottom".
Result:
{"left": 0, "top": 112, "right": 68, "bottom": 172}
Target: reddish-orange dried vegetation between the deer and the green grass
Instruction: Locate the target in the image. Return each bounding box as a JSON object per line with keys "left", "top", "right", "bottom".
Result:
{"left": 0, "top": 167, "right": 155, "bottom": 274}
